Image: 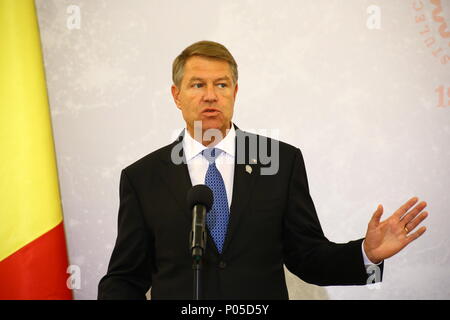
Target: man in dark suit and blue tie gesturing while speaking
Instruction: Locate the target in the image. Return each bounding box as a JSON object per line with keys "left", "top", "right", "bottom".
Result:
{"left": 98, "top": 41, "right": 428, "bottom": 299}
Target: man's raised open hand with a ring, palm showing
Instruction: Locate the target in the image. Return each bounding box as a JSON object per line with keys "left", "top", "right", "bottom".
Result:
{"left": 364, "top": 197, "right": 428, "bottom": 263}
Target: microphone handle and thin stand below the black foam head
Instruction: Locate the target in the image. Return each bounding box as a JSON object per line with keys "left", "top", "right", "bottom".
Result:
{"left": 190, "top": 205, "right": 206, "bottom": 300}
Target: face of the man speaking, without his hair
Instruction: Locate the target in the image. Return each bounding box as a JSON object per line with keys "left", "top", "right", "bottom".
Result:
{"left": 172, "top": 56, "right": 238, "bottom": 136}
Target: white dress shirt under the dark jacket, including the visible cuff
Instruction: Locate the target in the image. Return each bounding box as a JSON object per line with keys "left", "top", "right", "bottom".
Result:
{"left": 183, "top": 124, "right": 374, "bottom": 266}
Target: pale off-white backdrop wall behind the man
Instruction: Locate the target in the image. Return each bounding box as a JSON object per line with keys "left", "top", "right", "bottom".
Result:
{"left": 36, "top": 0, "right": 450, "bottom": 299}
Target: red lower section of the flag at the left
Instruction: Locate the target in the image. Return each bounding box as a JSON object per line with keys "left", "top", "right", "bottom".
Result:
{"left": 0, "top": 222, "right": 72, "bottom": 300}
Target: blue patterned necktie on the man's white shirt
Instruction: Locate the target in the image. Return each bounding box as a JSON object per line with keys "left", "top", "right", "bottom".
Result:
{"left": 203, "top": 148, "right": 230, "bottom": 253}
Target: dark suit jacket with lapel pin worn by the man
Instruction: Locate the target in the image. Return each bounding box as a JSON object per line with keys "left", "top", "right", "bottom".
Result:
{"left": 98, "top": 129, "right": 380, "bottom": 299}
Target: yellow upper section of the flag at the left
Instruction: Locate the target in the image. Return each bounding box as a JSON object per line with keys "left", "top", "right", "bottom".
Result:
{"left": 0, "top": 0, "right": 62, "bottom": 261}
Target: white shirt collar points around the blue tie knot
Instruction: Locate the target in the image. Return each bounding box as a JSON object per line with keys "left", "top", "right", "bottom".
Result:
{"left": 183, "top": 123, "right": 236, "bottom": 161}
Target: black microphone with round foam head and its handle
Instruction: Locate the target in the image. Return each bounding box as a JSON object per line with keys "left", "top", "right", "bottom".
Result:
{"left": 187, "top": 184, "right": 213, "bottom": 262}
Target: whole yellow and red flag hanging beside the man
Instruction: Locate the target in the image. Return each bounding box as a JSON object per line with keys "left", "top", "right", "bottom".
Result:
{"left": 0, "top": 0, "right": 72, "bottom": 299}
